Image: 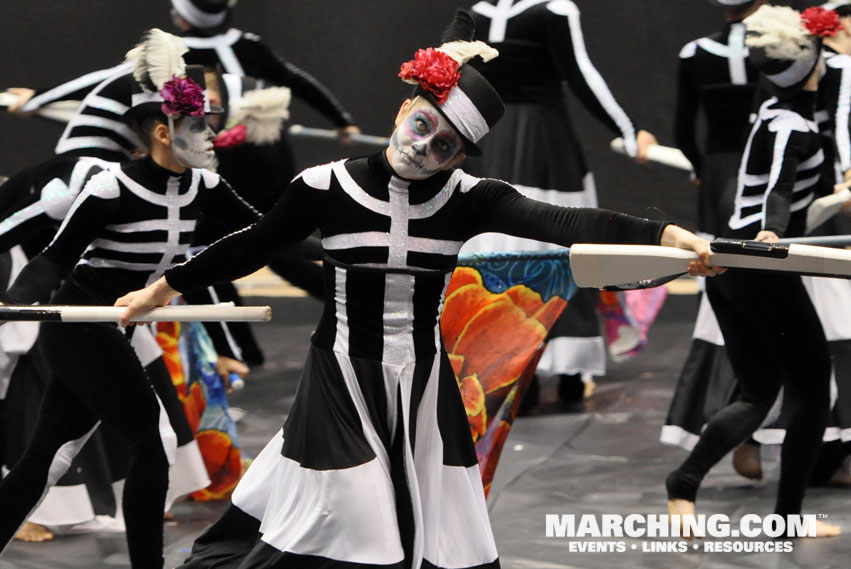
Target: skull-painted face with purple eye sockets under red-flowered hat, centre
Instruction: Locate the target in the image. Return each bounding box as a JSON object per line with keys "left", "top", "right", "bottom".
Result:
{"left": 387, "top": 99, "right": 464, "bottom": 180}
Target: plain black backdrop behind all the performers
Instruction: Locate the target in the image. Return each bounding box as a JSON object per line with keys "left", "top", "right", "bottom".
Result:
{"left": 0, "top": 0, "right": 817, "bottom": 227}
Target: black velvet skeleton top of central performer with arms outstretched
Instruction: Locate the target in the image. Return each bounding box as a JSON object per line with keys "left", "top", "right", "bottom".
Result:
{"left": 165, "top": 152, "right": 665, "bottom": 291}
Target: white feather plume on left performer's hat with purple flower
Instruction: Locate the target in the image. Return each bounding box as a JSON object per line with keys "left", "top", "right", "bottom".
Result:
{"left": 124, "top": 28, "right": 189, "bottom": 91}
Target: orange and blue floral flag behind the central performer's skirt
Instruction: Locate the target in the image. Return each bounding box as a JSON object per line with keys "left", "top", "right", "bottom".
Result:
{"left": 440, "top": 249, "right": 577, "bottom": 494}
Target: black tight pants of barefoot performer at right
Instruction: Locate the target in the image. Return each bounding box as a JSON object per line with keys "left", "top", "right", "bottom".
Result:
{"left": 667, "top": 269, "right": 830, "bottom": 515}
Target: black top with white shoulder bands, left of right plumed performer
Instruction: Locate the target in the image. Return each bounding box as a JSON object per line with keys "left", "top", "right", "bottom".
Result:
{"left": 674, "top": 22, "right": 758, "bottom": 177}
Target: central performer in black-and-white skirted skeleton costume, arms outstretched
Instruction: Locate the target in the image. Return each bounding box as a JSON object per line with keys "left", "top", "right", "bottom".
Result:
{"left": 116, "top": 10, "right": 714, "bottom": 569}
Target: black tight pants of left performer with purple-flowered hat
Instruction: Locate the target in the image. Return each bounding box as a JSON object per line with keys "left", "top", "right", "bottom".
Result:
{"left": 0, "top": 324, "right": 168, "bottom": 569}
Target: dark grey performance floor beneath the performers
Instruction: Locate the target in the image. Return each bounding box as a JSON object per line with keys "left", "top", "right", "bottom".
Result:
{"left": 0, "top": 290, "right": 851, "bottom": 569}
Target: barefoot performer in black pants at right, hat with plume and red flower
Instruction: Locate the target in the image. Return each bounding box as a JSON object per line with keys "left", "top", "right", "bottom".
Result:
{"left": 666, "top": 6, "right": 841, "bottom": 536}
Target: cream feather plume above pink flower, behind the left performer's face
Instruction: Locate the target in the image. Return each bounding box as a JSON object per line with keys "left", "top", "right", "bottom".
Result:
{"left": 228, "top": 87, "right": 292, "bottom": 144}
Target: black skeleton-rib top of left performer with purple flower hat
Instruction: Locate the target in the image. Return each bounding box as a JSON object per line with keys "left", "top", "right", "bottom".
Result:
{"left": 3, "top": 158, "right": 258, "bottom": 305}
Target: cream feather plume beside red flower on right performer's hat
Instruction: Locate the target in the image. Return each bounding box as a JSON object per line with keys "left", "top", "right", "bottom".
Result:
{"left": 744, "top": 4, "right": 815, "bottom": 60}
